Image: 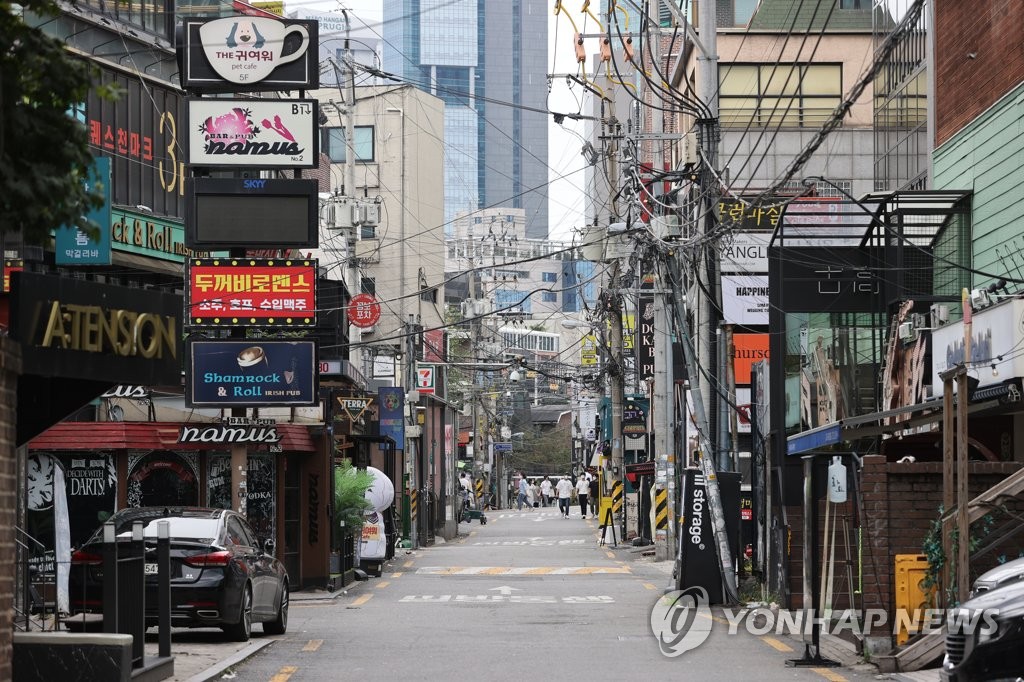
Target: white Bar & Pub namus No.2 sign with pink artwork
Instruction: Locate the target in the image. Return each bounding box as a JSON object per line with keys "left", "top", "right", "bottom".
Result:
{"left": 186, "top": 99, "right": 319, "bottom": 168}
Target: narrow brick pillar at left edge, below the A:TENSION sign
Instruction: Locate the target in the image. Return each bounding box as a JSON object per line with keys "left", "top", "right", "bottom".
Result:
{"left": 0, "top": 337, "right": 22, "bottom": 680}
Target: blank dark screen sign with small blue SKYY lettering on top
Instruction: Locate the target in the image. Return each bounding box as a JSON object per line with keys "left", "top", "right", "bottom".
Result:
{"left": 185, "top": 177, "right": 318, "bottom": 250}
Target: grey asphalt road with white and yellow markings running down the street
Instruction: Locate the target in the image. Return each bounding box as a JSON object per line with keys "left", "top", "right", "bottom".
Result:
{"left": 193, "top": 509, "right": 873, "bottom": 682}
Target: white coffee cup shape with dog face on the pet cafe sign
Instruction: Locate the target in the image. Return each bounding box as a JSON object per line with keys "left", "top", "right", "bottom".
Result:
{"left": 199, "top": 16, "right": 309, "bottom": 84}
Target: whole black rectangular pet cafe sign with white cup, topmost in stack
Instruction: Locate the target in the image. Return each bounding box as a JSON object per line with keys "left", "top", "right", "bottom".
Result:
{"left": 178, "top": 16, "right": 319, "bottom": 92}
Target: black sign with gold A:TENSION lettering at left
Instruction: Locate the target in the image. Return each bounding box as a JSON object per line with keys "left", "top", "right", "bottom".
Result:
{"left": 10, "top": 272, "right": 181, "bottom": 386}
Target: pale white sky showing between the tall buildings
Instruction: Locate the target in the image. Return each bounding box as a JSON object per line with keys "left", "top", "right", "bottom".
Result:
{"left": 285, "top": 0, "right": 598, "bottom": 241}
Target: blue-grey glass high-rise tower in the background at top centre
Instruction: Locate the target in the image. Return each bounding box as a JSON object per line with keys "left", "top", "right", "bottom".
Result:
{"left": 384, "top": 0, "right": 551, "bottom": 239}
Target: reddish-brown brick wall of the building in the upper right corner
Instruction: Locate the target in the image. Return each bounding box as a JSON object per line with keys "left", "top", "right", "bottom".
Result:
{"left": 935, "top": 0, "right": 1024, "bottom": 145}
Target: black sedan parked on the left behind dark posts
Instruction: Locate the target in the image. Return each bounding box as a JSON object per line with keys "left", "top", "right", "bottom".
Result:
{"left": 68, "top": 507, "right": 289, "bottom": 641}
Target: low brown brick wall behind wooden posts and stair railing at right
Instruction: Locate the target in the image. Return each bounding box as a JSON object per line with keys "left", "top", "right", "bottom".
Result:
{"left": 861, "top": 455, "right": 1024, "bottom": 635}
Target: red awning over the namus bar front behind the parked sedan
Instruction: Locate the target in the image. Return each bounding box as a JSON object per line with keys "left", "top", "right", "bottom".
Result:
{"left": 29, "top": 422, "right": 316, "bottom": 453}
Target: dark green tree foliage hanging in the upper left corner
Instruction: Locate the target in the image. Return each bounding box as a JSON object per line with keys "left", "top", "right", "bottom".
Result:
{"left": 0, "top": 0, "right": 102, "bottom": 244}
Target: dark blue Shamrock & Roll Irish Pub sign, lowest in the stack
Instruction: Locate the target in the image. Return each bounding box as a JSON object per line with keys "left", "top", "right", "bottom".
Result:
{"left": 185, "top": 339, "right": 319, "bottom": 408}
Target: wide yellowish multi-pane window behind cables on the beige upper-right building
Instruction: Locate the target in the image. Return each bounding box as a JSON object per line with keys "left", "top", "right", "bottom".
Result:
{"left": 719, "top": 63, "right": 843, "bottom": 128}
